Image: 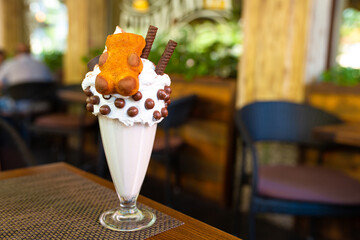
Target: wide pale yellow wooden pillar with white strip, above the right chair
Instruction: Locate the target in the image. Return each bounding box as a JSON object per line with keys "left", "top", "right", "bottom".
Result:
{"left": 236, "top": 0, "right": 332, "bottom": 107}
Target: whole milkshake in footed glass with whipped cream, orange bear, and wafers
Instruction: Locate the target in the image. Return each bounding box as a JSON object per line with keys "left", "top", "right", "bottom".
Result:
{"left": 82, "top": 26, "right": 176, "bottom": 231}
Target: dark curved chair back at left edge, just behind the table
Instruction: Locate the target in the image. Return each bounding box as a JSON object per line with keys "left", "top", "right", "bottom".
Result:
{"left": 0, "top": 118, "right": 36, "bottom": 170}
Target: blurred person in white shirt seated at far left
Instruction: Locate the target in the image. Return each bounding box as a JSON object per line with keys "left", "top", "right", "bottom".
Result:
{"left": 0, "top": 44, "right": 53, "bottom": 89}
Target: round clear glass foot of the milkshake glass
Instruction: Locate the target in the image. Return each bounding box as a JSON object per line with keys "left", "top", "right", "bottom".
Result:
{"left": 99, "top": 208, "right": 156, "bottom": 231}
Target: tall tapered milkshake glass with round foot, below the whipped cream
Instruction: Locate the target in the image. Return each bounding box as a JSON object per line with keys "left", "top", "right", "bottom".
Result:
{"left": 99, "top": 116, "right": 157, "bottom": 231}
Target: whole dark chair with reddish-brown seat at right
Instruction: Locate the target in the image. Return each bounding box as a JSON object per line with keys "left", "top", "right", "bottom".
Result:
{"left": 234, "top": 101, "right": 360, "bottom": 240}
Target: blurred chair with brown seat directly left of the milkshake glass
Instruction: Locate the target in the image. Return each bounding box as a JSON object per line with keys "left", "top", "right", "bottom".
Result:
{"left": 28, "top": 84, "right": 97, "bottom": 167}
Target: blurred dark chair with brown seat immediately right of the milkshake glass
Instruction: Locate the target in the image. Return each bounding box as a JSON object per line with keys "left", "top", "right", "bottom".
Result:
{"left": 151, "top": 95, "right": 197, "bottom": 205}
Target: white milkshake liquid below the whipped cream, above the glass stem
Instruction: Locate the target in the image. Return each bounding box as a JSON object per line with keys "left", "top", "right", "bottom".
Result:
{"left": 99, "top": 116, "right": 156, "bottom": 199}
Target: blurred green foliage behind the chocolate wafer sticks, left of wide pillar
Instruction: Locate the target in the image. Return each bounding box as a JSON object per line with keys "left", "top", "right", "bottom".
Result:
{"left": 149, "top": 21, "right": 242, "bottom": 80}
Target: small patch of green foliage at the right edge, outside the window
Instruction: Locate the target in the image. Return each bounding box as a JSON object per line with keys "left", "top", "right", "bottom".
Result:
{"left": 320, "top": 66, "right": 360, "bottom": 86}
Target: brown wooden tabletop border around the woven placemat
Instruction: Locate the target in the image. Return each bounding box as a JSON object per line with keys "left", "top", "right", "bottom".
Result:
{"left": 0, "top": 163, "right": 239, "bottom": 240}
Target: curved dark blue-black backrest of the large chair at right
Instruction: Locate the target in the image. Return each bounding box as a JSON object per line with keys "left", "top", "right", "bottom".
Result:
{"left": 236, "top": 101, "right": 342, "bottom": 145}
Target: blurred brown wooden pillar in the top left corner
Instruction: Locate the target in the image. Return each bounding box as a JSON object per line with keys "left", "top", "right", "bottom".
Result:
{"left": 0, "top": 0, "right": 29, "bottom": 55}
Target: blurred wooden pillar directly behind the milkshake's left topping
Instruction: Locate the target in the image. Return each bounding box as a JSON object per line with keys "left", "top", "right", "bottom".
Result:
{"left": 64, "top": 0, "right": 107, "bottom": 84}
